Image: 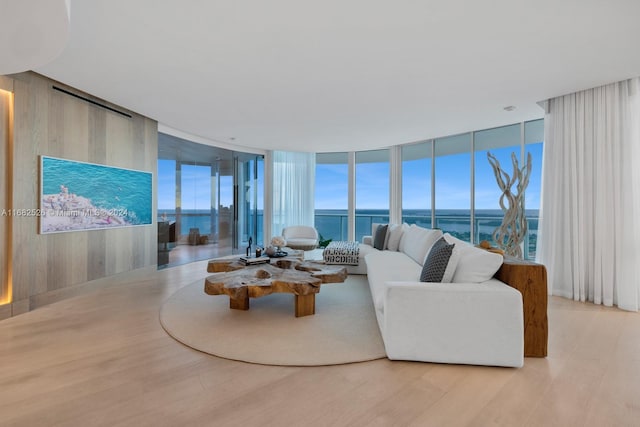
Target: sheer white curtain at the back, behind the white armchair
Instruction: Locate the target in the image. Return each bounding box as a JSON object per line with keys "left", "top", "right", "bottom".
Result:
{"left": 271, "top": 151, "right": 316, "bottom": 236}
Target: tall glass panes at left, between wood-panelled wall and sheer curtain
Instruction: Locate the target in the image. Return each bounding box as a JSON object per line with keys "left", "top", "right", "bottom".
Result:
{"left": 157, "top": 133, "right": 264, "bottom": 267}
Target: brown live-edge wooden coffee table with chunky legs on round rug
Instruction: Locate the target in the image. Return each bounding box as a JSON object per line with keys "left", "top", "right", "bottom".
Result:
{"left": 204, "top": 257, "right": 347, "bottom": 317}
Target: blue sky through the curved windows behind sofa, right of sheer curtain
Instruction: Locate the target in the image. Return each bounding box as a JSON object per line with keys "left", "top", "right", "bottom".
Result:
{"left": 316, "top": 143, "right": 542, "bottom": 209}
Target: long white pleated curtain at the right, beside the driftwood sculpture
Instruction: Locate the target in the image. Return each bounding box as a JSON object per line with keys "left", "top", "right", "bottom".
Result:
{"left": 537, "top": 78, "right": 640, "bottom": 311}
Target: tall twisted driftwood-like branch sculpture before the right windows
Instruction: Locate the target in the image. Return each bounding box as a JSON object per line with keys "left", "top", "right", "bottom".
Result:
{"left": 487, "top": 153, "right": 531, "bottom": 259}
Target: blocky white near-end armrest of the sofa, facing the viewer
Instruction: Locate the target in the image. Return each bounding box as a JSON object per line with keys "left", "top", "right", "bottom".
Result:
{"left": 374, "top": 279, "right": 524, "bottom": 367}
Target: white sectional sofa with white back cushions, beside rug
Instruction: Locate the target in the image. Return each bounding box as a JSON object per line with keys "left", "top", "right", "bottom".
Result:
{"left": 361, "top": 224, "right": 524, "bottom": 367}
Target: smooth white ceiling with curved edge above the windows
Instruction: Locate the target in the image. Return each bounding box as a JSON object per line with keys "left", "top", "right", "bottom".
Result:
{"left": 28, "top": 0, "right": 640, "bottom": 152}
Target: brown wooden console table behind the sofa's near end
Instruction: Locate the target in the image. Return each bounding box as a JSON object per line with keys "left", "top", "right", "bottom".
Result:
{"left": 495, "top": 257, "right": 549, "bottom": 357}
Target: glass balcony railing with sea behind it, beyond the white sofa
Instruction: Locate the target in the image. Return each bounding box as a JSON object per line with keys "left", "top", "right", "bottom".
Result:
{"left": 315, "top": 212, "right": 538, "bottom": 260}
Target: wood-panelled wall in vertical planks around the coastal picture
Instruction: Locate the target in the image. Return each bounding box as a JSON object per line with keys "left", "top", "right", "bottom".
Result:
{"left": 5, "top": 72, "right": 158, "bottom": 315}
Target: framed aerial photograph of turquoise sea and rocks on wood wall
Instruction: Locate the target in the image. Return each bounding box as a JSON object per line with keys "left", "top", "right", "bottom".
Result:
{"left": 38, "top": 156, "right": 153, "bottom": 234}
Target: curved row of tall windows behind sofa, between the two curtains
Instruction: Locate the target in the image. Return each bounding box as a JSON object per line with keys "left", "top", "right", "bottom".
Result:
{"left": 316, "top": 119, "right": 544, "bottom": 259}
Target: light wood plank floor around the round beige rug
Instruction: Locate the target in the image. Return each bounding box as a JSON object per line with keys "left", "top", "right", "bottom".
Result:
{"left": 0, "top": 262, "right": 640, "bottom": 426}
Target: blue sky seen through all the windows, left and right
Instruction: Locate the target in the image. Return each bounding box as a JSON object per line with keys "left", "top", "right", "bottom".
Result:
{"left": 158, "top": 143, "right": 542, "bottom": 209}
